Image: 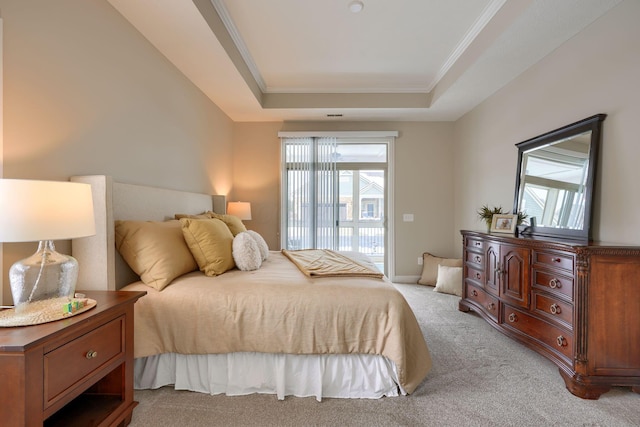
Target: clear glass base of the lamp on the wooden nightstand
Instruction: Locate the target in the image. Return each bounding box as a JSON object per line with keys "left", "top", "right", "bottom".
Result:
{"left": 9, "top": 240, "right": 78, "bottom": 311}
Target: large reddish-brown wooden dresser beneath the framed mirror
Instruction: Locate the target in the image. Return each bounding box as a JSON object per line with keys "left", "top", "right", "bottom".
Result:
{"left": 459, "top": 231, "right": 640, "bottom": 399}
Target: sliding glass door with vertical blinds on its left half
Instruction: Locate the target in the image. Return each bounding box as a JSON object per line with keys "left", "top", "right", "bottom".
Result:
{"left": 282, "top": 138, "right": 389, "bottom": 272}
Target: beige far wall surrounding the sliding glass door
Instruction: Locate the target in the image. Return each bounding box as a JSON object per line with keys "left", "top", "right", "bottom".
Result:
{"left": 233, "top": 122, "right": 455, "bottom": 281}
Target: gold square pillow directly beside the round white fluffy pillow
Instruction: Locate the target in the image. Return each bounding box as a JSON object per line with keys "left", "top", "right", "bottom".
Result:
{"left": 180, "top": 218, "right": 235, "bottom": 276}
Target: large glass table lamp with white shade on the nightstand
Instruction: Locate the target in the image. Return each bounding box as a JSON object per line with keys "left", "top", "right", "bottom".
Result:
{"left": 0, "top": 179, "right": 96, "bottom": 313}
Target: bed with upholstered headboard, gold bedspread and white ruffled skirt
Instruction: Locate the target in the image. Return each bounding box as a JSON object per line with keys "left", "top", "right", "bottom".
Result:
{"left": 72, "top": 176, "right": 431, "bottom": 400}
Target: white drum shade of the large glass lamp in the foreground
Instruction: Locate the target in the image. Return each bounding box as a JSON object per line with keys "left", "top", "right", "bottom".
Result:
{"left": 0, "top": 179, "right": 96, "bottom": 242}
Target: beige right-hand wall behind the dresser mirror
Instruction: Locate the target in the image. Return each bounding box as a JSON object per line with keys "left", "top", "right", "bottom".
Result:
{"left": 452, "top": 0, "right": 640, "bottom": 253}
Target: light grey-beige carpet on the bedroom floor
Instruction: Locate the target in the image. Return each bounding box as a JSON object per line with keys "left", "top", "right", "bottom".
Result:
{"left": 130, "top": 284, "right": 640, "bottom": 427}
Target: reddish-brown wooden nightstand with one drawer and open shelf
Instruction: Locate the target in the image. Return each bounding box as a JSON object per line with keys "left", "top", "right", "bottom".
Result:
{"left": 0, "top": 291, "right": 145, "bottom": 427}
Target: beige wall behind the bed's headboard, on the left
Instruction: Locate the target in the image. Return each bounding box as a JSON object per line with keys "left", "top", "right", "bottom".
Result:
{"left": 0, "top": 0, "right": 233, "bottom": 301}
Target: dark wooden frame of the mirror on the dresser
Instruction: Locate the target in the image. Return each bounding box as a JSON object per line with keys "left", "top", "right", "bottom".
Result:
{"left": 513, "top": 114, "right": 607, "bottom": 240}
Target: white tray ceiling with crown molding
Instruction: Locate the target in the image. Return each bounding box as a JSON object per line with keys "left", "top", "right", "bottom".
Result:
{"left": 108, "top": 0, "right": 620, "bottom": 121}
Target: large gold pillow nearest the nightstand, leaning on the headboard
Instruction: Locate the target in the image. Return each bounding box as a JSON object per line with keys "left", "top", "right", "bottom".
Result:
{"left": 115, "top": 221, "right": 198, "bottom": 291}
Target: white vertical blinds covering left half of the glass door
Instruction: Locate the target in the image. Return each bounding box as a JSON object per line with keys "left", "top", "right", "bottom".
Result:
{"left": 282, "top": 137, "right": 338, "bottom": 249}
